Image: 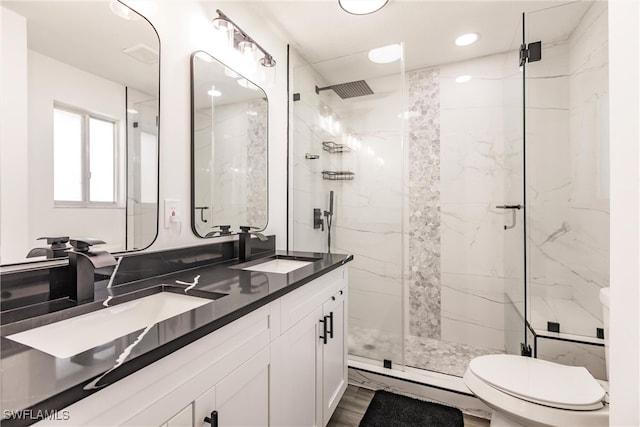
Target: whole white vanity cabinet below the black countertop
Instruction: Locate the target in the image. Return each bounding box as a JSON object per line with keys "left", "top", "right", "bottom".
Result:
{"left": 31, "top": 266, "right": 347, "bottom": 427}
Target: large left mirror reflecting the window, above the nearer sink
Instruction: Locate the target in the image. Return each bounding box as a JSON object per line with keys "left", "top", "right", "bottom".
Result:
{"left": 0, "top": 0, "right": 160, "bottom": 265}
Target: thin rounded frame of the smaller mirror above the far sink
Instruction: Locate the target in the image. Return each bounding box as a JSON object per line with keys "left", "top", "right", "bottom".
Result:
{"left": 189, "top": 50, "right": 269, "bottom": 239}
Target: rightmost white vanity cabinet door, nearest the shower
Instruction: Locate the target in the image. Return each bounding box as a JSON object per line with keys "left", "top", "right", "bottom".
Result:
{"left": 322, "top": 290, "right": 347, "bottom": 425}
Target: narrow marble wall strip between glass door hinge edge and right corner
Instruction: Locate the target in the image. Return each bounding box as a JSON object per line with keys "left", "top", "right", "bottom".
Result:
{"left": 526, "top": 43, "right": 571, "bottom": 304}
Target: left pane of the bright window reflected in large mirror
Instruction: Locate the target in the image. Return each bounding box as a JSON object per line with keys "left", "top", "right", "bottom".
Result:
{"left": 53, "top": 109, "right": 83, "bottom": 201}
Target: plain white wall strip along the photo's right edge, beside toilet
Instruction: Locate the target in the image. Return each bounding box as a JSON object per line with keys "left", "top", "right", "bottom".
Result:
{"left": 609, "top": 0, "right": 640, "bottom": 426}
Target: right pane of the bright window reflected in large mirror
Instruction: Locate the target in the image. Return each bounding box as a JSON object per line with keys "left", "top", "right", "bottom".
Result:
{"left": 89, "top": 117, "right": 115, "bottom": 202}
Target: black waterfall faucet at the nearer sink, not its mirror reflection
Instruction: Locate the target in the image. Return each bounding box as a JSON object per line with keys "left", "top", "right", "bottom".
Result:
{"left": 69, "top": 238, "right": 116, "bottom": 302}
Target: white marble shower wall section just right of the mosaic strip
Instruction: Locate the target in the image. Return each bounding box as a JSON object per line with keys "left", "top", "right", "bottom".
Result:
{"left": 440, "top": 54, "right": 511, "bottom": 352}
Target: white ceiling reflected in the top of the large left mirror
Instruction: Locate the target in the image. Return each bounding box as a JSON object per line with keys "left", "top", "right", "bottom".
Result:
{"left": 1, "top": 0, "right": 160, "bottom": 98}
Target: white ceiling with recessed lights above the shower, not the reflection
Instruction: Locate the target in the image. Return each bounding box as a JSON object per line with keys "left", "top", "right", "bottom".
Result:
{"left": 253, "top": 0, "right": 591, "bottom": 83}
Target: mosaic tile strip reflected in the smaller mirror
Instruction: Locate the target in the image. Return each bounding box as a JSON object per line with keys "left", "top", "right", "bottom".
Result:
{"left": 247, "top": 100, "right": 268, "bottom": 228}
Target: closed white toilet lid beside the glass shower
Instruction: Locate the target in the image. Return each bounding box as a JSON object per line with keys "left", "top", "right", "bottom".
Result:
{"left": 469, "top": 354, "right": 605, "bottom": 411}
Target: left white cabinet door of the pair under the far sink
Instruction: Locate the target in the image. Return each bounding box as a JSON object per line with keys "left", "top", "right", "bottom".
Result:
{"left": 270, "top": 307, "right": 322, "bottom": 427}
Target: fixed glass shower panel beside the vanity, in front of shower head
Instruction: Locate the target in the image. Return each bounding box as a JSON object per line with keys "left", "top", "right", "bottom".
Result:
{"left": 289, "top": 46, "right": 406, "bottom": 368}
